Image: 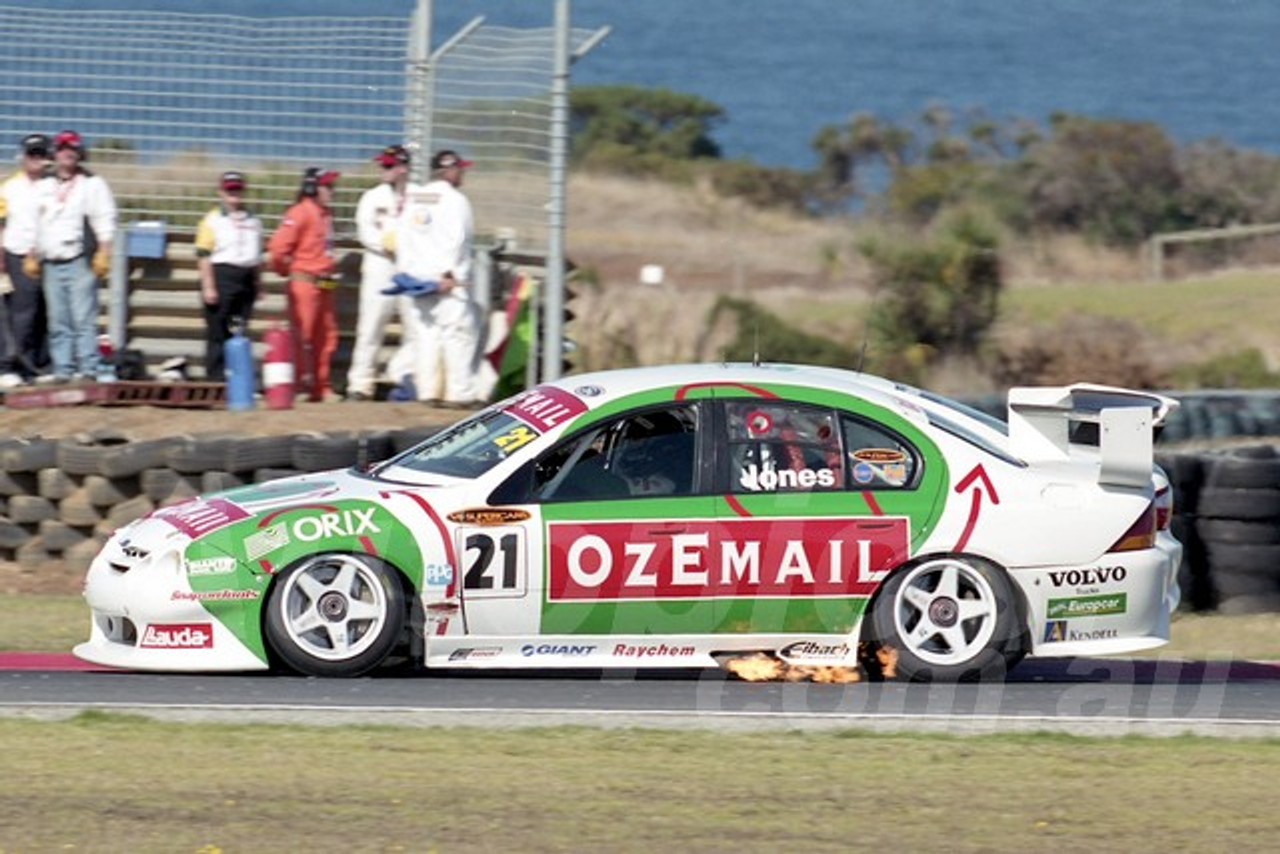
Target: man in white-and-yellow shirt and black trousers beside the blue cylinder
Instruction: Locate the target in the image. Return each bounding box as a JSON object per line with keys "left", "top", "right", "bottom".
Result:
{"left": 196, "top": 172, "right": 262, "bottom": 383}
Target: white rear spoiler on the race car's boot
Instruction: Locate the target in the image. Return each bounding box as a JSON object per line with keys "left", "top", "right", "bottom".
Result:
{"left": 1009, "top": 383, "right": 1178, "bottom": 487}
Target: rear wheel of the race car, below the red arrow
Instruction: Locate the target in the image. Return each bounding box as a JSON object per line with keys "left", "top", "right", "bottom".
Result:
{"left": 870, "top": 556, "right": 1027, "bottom": 682}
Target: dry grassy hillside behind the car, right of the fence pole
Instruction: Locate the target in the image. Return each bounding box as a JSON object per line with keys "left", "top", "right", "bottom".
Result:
{"left": 568, "top": 174, "right": 1280, "bottom": 394}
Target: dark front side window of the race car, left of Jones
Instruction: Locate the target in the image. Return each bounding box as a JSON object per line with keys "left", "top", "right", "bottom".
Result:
{"left": 534, "top": 406, "right": 698, "bottom": 501}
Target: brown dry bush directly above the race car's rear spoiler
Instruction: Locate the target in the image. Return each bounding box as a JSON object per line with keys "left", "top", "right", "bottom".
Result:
{"left": 991, "top": 315, "right": 1167, "bottom": 388}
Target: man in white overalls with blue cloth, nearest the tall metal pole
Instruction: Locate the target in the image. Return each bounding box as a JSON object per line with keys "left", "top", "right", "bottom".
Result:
{"left": 393, "top": 150, "right": 480, "bottom": 408}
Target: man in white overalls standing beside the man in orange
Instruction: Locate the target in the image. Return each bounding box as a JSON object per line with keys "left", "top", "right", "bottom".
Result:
{"left": 347, "top": 145, "right": 413, "bottom": 401}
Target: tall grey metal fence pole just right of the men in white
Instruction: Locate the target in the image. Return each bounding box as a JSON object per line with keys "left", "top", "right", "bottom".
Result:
{"left": 541, "top": 0, "right": 570, "bottom": 382}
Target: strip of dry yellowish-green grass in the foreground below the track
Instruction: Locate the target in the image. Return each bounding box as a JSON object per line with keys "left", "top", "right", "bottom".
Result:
{"left": 0, "top": 714, "right": 1280, "bottom": 854}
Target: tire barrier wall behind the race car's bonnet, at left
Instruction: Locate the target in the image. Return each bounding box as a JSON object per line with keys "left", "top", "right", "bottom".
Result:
{"left": 0, "top": 426, "right": 439, "bottom": 588}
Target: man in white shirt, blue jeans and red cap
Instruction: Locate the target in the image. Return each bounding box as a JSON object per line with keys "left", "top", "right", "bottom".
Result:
{"left": 36, "top": 131, "right": 116, "bottom": 382}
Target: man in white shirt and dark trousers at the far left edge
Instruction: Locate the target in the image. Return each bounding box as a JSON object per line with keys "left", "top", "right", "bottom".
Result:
{"left": 0, "top": 133, "right": 54, "bottom": 388}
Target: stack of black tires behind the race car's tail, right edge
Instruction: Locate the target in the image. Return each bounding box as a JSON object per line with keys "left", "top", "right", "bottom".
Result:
{"left": 1184, "top": 444, "right": 1280, "bottom": 613}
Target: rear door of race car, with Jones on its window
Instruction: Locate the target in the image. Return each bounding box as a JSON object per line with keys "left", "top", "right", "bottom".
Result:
{"left": 716, "top": 398, "right": 938, "bottom": 632}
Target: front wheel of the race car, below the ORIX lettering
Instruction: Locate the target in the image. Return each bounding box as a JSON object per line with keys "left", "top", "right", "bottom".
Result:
{"left": 265, "top": 553, "right": 407, "bottom": 677}
